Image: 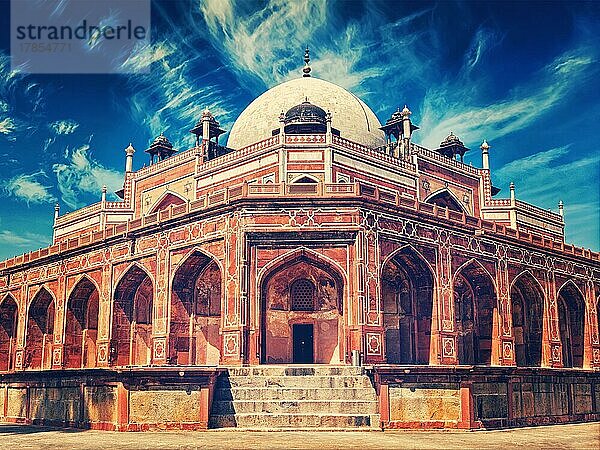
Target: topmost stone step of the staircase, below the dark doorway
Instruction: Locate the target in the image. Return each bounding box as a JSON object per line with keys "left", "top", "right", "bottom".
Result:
{"left": 227, "top": 365, "right": 365, "bottom": 377}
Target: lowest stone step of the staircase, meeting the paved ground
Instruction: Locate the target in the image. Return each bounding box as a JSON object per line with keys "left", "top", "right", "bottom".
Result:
{"left": 209, "top": 413, "right": 380, "bottom": 430}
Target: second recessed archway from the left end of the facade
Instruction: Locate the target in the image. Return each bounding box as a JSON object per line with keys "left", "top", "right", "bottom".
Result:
{"left": 23, "top": 287, "right": 55, "bottom": 369}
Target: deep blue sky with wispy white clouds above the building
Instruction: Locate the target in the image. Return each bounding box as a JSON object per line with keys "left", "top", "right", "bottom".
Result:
{"left": 0, "top": 0, "right": 600, "bottom": 259}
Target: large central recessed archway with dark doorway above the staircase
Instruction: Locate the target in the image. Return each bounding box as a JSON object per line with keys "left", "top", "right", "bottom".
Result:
{"left": 260, "top": 251, "right": 345, "bottom": 364}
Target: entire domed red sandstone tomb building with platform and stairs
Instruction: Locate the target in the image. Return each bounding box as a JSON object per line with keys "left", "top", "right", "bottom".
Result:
{"left": 0, "top": 52, "right": 600, "bottom": 430}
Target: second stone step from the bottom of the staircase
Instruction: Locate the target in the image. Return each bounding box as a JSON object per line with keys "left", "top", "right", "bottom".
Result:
{"left": 212, "top": 398, "right": 377, "bottom": 416}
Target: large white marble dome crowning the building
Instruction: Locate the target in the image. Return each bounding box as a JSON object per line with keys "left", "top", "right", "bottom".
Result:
{"left": 227, "top": 77, "right": 385, "bottom": 149}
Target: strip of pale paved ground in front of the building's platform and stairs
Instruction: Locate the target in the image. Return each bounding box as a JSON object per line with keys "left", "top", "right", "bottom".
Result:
{"left": 0, "top": 423, "right": 600, "bottom": 450}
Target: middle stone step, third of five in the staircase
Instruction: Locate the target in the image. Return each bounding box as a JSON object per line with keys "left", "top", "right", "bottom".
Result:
{"left": 214, "top": 387, "right": 377, "bottom": 401}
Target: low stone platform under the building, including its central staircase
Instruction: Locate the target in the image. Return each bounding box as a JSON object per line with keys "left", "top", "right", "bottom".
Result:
{"left": 0, "top": 365, "right": 600, "bottom": 431}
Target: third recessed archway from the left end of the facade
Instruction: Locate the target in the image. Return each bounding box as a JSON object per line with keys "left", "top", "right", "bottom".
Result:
{"left": 64, "top": 277, "right": 99, "bottom": 368}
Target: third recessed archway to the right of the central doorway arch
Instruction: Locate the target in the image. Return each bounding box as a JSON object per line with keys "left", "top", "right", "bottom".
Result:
{"left": 510, "top": 272, "right": 544, "bottom": 367}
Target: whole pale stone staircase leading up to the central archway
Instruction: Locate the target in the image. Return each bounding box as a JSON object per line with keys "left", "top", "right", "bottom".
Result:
{"left": 209, "top": 366, "right": 380, "bottom": 430}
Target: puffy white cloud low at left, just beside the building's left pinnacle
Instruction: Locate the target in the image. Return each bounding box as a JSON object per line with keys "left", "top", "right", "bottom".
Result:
{"left": 52, "top": 144, "right": 123, "bottom": 209}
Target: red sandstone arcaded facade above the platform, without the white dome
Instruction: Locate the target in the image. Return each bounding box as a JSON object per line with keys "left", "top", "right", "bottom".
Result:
{"left": 0, "top": 68, "right": 600, "bottom": 429}
